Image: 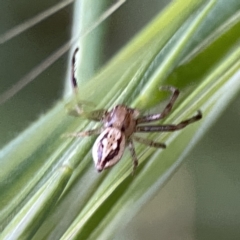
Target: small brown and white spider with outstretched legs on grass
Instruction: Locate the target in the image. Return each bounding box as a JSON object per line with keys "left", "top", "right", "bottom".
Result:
{"left": 67, "top": 48, "right": 202, "bottom": 173}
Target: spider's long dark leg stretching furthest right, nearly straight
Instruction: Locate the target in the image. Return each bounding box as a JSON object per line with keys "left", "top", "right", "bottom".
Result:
{"left": 136, "top": 111, "right": 202, "bottom": 132}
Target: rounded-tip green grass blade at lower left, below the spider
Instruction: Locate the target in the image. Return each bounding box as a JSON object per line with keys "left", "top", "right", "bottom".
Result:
{"left": 0, "top": 167, "right": 72, "bottom": 239}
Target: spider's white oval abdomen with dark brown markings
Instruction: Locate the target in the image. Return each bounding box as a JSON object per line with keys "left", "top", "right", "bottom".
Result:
{"left": 92, "top": 127, "right": 125, "bottom": 172}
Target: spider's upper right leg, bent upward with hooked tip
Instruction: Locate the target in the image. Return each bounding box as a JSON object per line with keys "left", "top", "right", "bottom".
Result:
{"left": 137, "top": 86, "right": 179, "bottom": 124}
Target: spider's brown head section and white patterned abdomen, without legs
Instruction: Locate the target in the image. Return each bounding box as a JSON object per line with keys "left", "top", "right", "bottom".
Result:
{"left": 92, "top": 105, "right": 139, "bottom": 172}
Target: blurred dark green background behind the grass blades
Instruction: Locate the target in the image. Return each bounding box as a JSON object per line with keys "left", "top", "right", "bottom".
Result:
{"left": 0, "top": 0, "right": 240, "bottom": 240}
